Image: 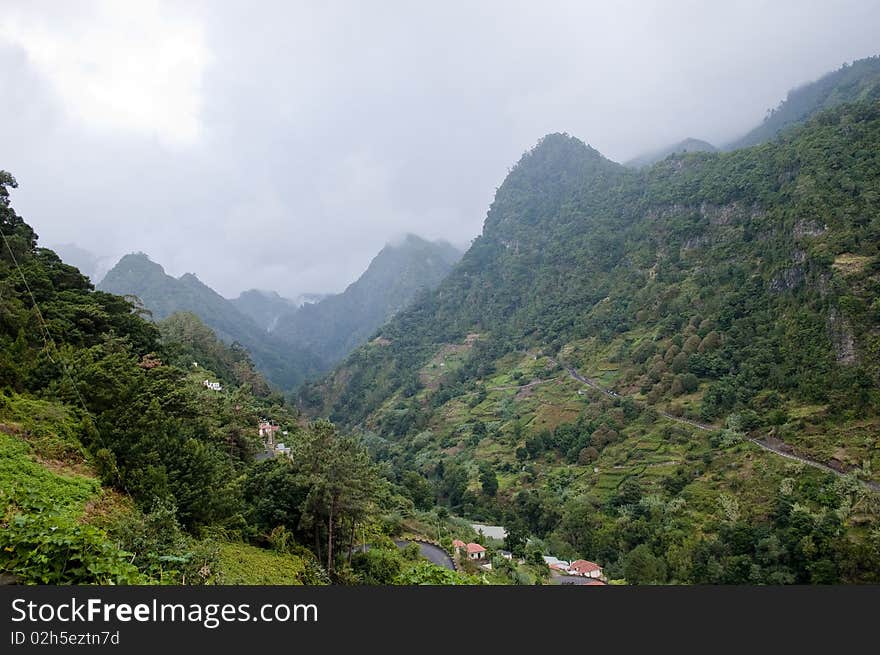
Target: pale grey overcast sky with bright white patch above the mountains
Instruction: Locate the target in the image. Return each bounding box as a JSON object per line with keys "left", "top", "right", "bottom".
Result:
{"left": 0, "top": 0, "right": 880, "bottom": 296}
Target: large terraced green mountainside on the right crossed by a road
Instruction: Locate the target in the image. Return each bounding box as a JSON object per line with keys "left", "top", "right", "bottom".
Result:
{"left": 302, "top": 103, "right": 880, "bottom": 583}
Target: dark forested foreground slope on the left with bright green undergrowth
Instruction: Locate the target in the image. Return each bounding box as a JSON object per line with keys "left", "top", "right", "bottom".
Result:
{"left": 0, "top": 177, "right": 398, "bottom": 584}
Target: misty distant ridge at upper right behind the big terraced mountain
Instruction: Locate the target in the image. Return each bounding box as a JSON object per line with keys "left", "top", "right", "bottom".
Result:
{"left": 724, "top": 55, "right": 880, "bottom": 150}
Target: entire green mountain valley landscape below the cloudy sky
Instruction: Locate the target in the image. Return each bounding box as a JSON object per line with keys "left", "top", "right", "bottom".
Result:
{"left": 0, "top": 57, "right": 880, "bottom": 586}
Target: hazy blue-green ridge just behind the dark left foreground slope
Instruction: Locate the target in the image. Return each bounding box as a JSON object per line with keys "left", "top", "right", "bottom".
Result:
{"left": 99, "top": 253, "right": 325, "bottom": 391}
